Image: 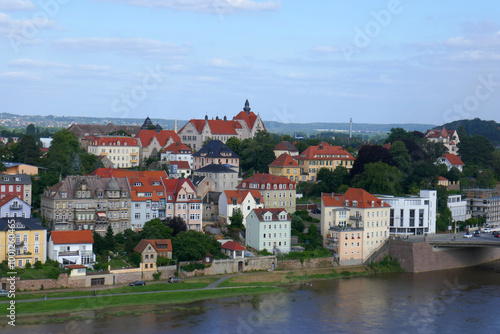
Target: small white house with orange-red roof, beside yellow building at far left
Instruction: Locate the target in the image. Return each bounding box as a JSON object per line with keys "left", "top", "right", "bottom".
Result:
{"left": 48, "top": 230, "right": 95, "bottom": 267}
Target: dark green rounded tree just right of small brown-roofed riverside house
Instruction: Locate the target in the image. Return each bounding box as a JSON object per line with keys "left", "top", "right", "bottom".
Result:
{"left": 172, "top": 230, "right": 224, "bottom": 261}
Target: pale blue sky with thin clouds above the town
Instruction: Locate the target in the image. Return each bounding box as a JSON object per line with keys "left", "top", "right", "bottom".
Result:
{"left": 0, "top": 0, "right": 500, "bottom": 124}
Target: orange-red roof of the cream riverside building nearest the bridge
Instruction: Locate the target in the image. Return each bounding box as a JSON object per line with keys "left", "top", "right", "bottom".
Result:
{"left": 321, "top": 188, "right": 391, "bottom": 209}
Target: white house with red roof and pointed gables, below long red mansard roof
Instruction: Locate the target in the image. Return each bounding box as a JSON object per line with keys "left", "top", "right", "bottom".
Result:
{"left": 219, "top": 189, "right": 264, "bottom": 226}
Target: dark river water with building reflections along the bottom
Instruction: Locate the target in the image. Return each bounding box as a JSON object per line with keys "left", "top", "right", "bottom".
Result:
{"left": 4, "top": 261, "right": 500, "bottom": 334}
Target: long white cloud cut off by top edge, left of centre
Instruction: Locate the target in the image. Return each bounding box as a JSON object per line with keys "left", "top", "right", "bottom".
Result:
{"left": 101, "top": 0, "right": 281, "bottom": 15}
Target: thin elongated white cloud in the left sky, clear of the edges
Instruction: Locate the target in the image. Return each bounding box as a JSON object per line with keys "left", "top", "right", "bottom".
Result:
{"left": 53, "top": 37, "right": 190, "bottom": 60}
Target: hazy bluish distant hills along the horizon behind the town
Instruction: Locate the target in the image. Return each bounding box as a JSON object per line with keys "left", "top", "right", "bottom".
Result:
{"left": 0, "top": 113, "right": 435, "bottom": 135}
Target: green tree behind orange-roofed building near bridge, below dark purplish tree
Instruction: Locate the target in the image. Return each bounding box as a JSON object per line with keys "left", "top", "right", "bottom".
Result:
{"left": 353, "top": 162, "right": 402, "bottom": 195}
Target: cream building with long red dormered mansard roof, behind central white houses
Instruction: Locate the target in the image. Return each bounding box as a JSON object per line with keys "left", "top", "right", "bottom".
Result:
{"left": 237, "top": 173, "right": 296, "bottom": 213}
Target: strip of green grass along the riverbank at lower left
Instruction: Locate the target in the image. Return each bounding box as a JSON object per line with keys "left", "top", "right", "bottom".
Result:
{"left": 0, "top": 287, "right": 283, "bottom": 316}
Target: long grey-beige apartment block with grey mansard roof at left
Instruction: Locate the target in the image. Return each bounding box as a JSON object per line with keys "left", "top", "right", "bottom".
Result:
{"left": 40, "top": 175, "right": 131, "bottom": 235}
